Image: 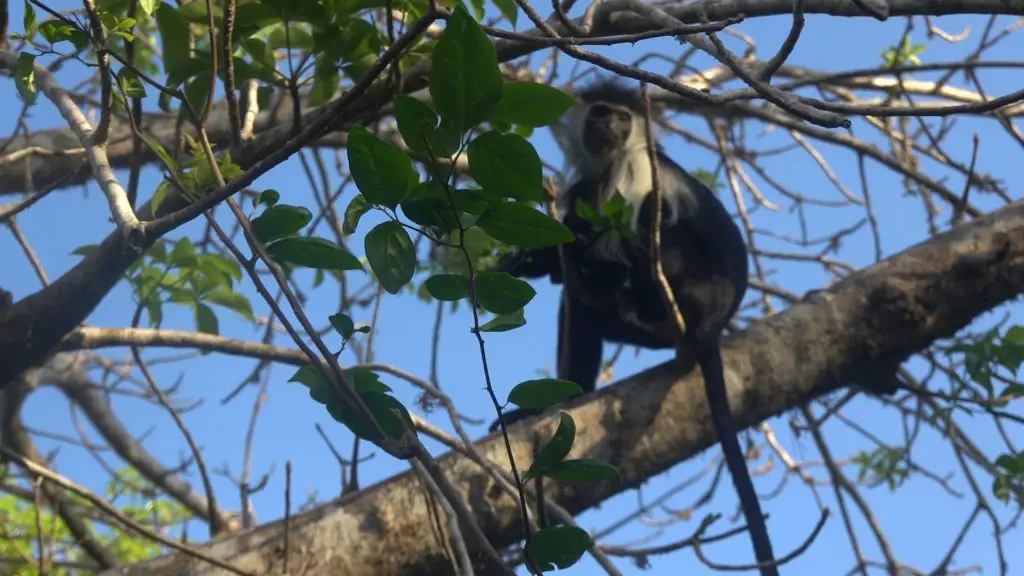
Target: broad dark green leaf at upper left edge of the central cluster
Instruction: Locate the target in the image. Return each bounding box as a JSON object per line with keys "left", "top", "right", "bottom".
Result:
{"left": 348, "top": 126, "right": 420, "bottom": 208}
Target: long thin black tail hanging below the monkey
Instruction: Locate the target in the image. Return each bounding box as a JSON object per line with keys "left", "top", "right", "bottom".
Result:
{"left": 687, "top": 330, "right": 778, "bottom": 576}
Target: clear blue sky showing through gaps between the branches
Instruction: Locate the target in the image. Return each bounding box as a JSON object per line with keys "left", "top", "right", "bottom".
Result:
{"left": 0, "top": 2, "right": 1024, "bottom": 575}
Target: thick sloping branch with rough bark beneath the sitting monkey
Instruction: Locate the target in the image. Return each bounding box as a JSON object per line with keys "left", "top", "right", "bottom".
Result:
{"left": 101, "top": 204, "right": 1024, "bottom": 576}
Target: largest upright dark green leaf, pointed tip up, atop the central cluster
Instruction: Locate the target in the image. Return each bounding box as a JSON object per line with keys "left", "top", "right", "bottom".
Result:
{"left": 429, "top": 5, "right": 502, "bottom": 133}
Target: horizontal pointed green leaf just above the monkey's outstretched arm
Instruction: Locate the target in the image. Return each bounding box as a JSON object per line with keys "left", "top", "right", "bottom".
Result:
{"left": 476, "top": 203, "right": 575, "bottom": 248}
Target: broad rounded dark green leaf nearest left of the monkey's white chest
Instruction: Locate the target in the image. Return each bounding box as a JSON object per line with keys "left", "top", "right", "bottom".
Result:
{"left": 468, "top": 131, "right": 544, "bottom": 202}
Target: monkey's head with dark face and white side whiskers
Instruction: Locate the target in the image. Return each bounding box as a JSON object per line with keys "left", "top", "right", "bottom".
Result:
{"left": 565, "top": 79, "right": 646, "bottom": 177}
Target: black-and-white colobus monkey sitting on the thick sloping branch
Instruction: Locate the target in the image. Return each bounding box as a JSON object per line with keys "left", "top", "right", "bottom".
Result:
{"left": 500, "top": 81, "right": 778, "bottom": 574}
